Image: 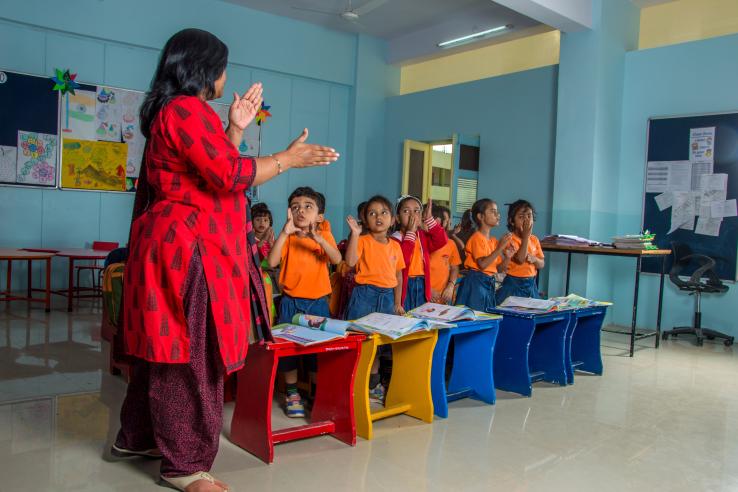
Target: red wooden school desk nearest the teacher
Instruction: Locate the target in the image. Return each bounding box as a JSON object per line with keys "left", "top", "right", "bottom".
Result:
{"left": 231, "top": 334, "right": 365, "bottom": 463}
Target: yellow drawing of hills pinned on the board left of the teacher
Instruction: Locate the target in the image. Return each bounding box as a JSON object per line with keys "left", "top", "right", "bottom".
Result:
{"left": 61, "top": 139, "right": 128, "bottom": 191}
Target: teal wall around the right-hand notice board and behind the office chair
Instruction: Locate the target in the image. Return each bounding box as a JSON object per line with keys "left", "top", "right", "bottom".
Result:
{"left": 613, "top": 31, "right": 738, "bottom": 336}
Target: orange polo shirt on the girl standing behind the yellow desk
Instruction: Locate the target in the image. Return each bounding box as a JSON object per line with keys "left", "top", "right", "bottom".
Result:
{"left": 354, "top": 234, "right": 405, "bottom": 288}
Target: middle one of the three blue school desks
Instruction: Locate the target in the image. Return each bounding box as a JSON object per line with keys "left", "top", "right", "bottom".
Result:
{"left": 493, "top": 307, "right": 573, "bottom": 396}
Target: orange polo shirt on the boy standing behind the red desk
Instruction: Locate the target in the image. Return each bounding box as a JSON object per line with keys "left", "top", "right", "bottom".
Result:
{"left": 279, "top": 231, "right": 336, "bottom": 299}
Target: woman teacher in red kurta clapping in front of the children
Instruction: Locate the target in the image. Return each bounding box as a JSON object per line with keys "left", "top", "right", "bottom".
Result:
{"left": 111, "top": 29, "right": 338, "bottom": 492}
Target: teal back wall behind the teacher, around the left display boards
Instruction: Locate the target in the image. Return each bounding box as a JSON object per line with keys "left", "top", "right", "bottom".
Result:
{"left": 0, "top": 0, "right": 399, "bottom": 287}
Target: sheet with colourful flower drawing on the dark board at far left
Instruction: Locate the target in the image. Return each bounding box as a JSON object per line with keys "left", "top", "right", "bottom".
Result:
{"left": 16, "top": 130, "right": 58, "bottom": 186}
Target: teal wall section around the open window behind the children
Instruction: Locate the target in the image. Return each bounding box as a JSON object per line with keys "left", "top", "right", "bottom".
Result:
{"left": 380, "top": 66, "right": 558, "bottom": 248}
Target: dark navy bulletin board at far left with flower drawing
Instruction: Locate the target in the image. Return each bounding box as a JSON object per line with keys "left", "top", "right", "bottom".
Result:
{"left": 0, "top": 70, "right": 59, "bottom": 188}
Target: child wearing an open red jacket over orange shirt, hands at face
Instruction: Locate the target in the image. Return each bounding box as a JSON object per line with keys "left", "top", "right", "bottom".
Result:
{"left": 392, "top": 195, "right": 448, "bottom": 313}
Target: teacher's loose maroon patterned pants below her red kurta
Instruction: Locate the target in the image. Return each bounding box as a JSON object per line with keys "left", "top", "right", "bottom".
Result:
{"left": 115, "top": 250, "right": 224, "bottom": 477}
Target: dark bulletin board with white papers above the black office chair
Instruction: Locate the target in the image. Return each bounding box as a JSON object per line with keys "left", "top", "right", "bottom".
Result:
{"left": 642, "top": 113, "right": 738, "bottom": 281}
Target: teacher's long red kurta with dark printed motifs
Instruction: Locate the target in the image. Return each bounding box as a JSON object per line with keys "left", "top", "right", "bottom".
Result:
{"left": 123, "top": 96, "right": 266, "bottom": 372}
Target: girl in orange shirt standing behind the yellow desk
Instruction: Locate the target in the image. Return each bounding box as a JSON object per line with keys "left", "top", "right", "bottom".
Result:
{"left": 346, "top": 195, "right": 405, "bottom": 403}
